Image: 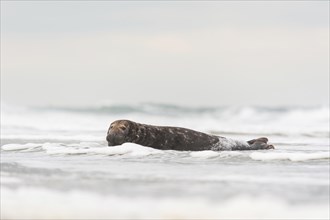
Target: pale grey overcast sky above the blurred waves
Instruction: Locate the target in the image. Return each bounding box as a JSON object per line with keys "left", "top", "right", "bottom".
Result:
{"left": 1, "top": 1, "right": 329, "bottom": 106}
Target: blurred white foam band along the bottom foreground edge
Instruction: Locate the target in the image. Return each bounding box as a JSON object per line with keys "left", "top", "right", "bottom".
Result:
{"left": 1, "top": 187, "right": 330, "bottom": 219}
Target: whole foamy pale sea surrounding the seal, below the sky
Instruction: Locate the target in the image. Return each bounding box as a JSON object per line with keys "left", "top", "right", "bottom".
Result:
{"left": 1, "top": 103, "right": 330, "bottom": 219}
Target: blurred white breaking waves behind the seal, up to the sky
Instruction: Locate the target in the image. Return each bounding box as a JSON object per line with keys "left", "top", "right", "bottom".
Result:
{"left": 1, "top": 103, "right": 330, "bottom": 141}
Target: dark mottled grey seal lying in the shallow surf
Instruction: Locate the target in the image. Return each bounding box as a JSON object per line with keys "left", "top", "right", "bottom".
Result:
{"left": 106, "top": 120, "right": 274, "bottom": 151}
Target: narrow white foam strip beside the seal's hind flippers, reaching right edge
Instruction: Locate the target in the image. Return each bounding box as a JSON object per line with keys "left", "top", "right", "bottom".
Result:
{"left": 249, "top": 152, "right": 330, "bottom": 161}
